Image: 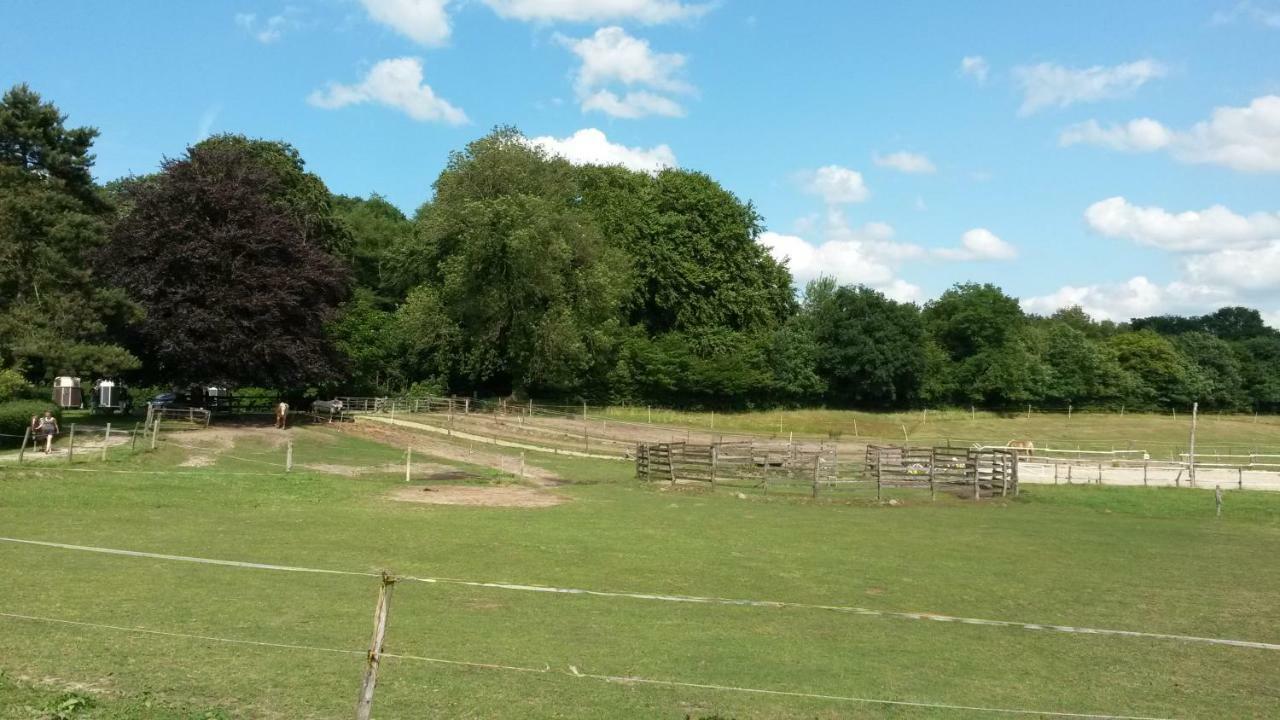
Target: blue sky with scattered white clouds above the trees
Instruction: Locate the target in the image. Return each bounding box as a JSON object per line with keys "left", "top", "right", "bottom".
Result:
{"left": 0, "top": 0, "right": 1280, "bottom": 319}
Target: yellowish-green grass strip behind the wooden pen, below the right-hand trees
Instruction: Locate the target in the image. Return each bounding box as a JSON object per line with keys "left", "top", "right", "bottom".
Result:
{"left": 601, "top": 406, "right": 1280, "bottom": 456}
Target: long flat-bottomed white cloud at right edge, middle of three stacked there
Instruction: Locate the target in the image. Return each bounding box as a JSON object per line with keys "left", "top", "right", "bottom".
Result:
{"left": 1084, "top": 197, "right": 1280, "bottom": 252}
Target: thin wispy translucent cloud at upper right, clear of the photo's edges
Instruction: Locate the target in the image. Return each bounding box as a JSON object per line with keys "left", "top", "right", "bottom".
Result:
{"left": 1014, "top": 59, "right": 1167, "bottom": 115}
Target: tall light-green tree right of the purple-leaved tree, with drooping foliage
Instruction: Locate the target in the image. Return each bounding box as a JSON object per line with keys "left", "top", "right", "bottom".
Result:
{"left": 396, "top": 128, "right": 628, "bottom": 393}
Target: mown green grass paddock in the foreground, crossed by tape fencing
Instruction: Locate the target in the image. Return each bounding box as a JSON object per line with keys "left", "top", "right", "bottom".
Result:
{"left": 0, "top": 418, "right": 1280, "bottom": 720}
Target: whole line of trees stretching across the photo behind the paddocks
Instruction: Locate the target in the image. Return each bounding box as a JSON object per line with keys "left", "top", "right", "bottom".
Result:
{"left": 0, "top": 86, "right": 1280, "bottom": 410}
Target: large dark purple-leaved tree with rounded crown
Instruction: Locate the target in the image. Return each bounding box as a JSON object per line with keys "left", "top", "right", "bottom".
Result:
{"left": 99, "top": 136, "right": 351, "bottom": 387}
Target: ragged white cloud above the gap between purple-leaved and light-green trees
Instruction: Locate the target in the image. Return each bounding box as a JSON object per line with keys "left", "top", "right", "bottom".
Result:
{"left": 307, "top": 58, "right": 467, "bottom": 126}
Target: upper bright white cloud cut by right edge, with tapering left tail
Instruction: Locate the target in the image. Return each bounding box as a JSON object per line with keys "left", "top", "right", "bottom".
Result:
{"left": 1059, "top": 95, "right": 1280, "bottom": 173}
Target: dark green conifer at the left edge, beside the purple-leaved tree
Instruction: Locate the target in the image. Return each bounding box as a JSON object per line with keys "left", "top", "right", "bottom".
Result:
{"left": 0, "top": 85, "right": 138, "bottom": 379}
